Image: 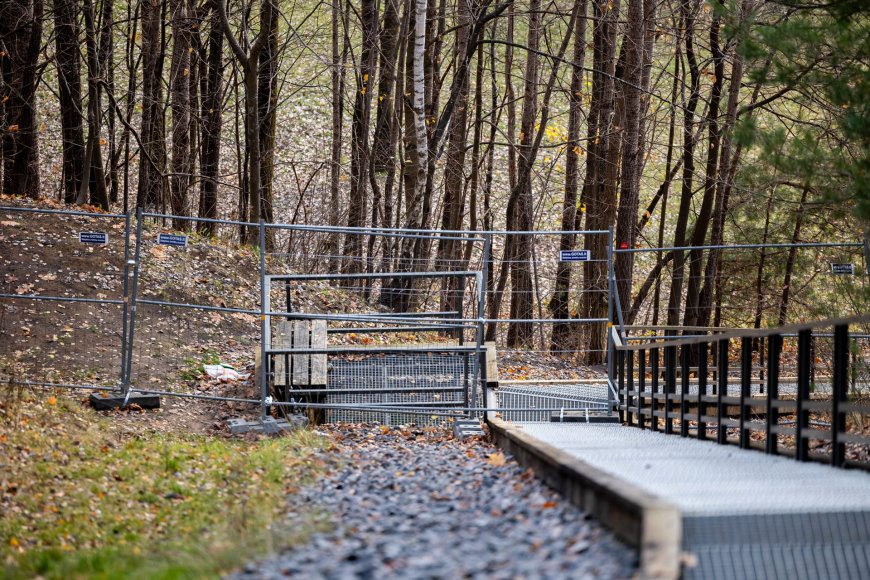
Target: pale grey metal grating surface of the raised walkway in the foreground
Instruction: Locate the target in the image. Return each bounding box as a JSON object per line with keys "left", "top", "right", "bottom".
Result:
{"left": 522, "top": 423, "right": 870, "bottom": 580}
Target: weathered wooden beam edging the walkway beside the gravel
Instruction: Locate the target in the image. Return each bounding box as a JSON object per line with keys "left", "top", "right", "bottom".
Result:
{"left": 487, "top": 417, "right": 682, "bottom": 580}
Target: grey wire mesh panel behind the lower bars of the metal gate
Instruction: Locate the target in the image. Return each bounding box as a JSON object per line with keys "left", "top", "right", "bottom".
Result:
{"left": 325, "top": 353, "right": 473, "bottom": 425}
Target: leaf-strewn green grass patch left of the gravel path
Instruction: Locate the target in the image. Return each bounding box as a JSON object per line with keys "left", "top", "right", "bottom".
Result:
{"left": 0, "top": 392, "right": 327, "bottom": 578}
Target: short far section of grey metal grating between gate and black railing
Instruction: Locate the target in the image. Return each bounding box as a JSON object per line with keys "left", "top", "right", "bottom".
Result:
{"left": 498, "top": 383, "right": 608, "bottom": 421}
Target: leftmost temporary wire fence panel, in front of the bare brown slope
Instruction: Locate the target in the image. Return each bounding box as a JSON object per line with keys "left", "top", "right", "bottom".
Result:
{"left": 0, "top": 207, "right": 130, "bottom": 389}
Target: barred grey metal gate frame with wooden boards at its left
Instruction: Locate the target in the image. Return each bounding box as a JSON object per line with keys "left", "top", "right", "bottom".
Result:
{"left": 263, "top": 271, "right": 483, "bottom": 424}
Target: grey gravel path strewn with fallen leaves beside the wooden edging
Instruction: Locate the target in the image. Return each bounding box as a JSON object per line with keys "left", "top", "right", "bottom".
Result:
{"left": 231, "top": 425, "right": 637, "bottom": 580}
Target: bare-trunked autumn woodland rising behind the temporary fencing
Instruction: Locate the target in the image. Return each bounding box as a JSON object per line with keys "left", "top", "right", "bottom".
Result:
{"left": 0, "top": 0, "right": 870, "bottom": 363}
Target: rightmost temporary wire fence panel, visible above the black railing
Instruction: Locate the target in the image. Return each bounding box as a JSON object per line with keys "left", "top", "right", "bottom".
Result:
{"left": 613, "top": 241, "right": 870, "bottom": 337}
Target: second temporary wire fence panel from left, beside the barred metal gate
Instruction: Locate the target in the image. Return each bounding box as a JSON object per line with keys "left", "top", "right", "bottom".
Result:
{"left": 125, "top": 212, "right": 262, "bottom": 408}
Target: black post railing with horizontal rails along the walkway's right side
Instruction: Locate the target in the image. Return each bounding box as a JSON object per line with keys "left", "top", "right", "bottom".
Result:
{"left": 611, "top": 315, "right": 870, "bottom": 467}
